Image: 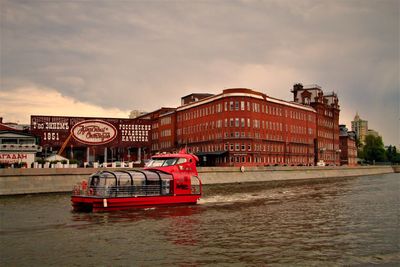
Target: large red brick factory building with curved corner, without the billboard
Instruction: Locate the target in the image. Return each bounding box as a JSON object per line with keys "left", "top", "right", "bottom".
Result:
{"left": 141, "top": 84, "right": 340, "bottom": 166}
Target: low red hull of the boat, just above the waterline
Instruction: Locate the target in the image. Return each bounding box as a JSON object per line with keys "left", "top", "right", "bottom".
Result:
{"left": 71, "top": 195, "right": 201, "bottom": 212}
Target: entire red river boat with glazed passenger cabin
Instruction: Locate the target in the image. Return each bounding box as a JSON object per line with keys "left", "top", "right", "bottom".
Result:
{"left": 71, "top": 151, "right": 202, "bottom": 212}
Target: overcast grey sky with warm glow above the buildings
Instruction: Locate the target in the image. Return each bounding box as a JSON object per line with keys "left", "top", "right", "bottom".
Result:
{"left": 0, "top": 0, "right": 400, "bottom": 145}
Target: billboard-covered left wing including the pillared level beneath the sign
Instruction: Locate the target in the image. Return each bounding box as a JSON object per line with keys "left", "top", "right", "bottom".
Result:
{"left": 31, "top": 115, "right": 151, "bottom": 163}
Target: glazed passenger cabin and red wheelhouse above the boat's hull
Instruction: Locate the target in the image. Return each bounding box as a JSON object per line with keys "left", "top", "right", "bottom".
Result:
{"left": 75, "top": 154, "right": 201, "bottom": 197}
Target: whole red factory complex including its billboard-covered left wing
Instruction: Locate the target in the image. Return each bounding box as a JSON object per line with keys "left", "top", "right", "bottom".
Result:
{"left": 25, "top": 84, "right": 341, "bottom": 166}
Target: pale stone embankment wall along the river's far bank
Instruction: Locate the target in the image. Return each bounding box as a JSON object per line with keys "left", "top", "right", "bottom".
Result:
{"left": 0, "top": 166, "right": 400, "bottom": 195}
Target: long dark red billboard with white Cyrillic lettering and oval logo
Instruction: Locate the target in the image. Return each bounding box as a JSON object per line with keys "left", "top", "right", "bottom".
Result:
{"left": 31, "top": 115, "right": 151, "bottom": 147}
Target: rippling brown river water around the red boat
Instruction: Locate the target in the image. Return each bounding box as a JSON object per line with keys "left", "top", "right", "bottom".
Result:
{"left": 0, "top": 174, "right": 400, "bottom": 266}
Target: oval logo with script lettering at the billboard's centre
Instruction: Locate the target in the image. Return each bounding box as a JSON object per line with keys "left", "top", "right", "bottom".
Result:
{"left": 71, "top": 120, "right": 117, "bottom": 145}
